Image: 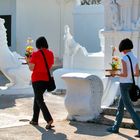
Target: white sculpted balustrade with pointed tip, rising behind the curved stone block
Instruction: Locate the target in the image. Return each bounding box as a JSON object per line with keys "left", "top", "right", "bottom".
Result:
{"left": 63, "top": 25, "right": 104, "bottom": 71}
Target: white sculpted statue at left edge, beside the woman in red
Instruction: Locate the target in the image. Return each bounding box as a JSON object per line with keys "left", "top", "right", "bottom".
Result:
{"left": 0, "top": 18, "right": 31, "bottom": 88}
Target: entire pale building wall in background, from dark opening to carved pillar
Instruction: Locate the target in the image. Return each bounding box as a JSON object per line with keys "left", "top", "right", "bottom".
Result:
{"left": 0, "top": 0, "right": 103, "bottom": 63}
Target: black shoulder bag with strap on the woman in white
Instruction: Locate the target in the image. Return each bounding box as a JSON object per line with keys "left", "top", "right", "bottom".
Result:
{"left": 127, "top": 55, "right": 140, "bottom": 102}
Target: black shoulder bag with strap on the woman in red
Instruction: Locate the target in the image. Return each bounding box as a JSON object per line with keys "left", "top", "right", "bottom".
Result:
{"left": 40, "top": 50, "right": 56, "bottom": 92}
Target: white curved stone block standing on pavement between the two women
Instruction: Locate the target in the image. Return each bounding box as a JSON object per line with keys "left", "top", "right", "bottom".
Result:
{"left": 62, "top": 73, "right": 103, "bottom": 121}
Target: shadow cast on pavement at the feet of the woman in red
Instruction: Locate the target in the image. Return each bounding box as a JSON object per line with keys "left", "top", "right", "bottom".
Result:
{"left": 33, "top": 126, "right": 68, "bottom": 140}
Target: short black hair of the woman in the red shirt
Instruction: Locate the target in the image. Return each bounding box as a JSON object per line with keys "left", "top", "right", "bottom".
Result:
{"left": 36, "top": 36, "right": 49, "bottom": 49}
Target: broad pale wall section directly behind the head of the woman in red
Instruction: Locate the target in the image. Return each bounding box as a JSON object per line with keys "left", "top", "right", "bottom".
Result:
{"left": 16, "top": 0, "right": 75, "bottom": 58}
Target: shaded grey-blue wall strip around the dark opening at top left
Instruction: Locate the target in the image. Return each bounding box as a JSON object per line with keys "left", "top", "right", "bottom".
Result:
{"left": 0, "top": 0, "right": 16, "bottom": 50}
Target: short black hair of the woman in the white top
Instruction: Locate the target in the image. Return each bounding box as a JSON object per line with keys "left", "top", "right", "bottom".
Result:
{"left": 119, "top": 38, "right": 133, "bottom": 52}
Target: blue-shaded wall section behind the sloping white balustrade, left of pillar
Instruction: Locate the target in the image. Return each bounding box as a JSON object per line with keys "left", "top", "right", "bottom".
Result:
{"left": 73, "top": 4, "right": 104, "bottom": 52}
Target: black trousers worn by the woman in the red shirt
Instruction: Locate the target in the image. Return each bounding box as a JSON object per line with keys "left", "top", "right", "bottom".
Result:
{"left": 32, "top": 81, "right": 52, "bottom": 123}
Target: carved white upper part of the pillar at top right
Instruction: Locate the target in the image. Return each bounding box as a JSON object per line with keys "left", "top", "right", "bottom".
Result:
{"left": 102, "top": 0, "right": 140, "bottom": 31}
